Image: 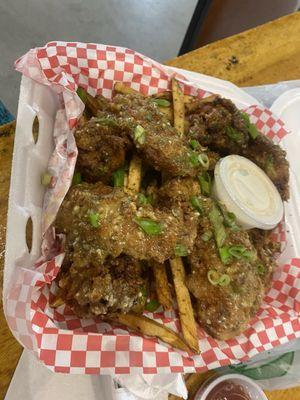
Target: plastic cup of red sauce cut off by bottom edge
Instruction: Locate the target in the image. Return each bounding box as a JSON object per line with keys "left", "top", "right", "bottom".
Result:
{"left": 194, "top": 374, "right": 268, "bottom": 400}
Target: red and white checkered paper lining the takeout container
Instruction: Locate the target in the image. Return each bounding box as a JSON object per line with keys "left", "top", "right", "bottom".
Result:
{"left": 5, "top": 42, "right": 300, "bottom": 374}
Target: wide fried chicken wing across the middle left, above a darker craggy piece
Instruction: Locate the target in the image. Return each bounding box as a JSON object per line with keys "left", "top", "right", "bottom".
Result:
{"left": 55, "top": 183, "right": 197, "bottom": 266}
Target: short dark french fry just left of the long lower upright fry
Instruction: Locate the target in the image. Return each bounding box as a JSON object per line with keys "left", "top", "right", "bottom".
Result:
{"left": 151, "top": 262, "right": 172, "bottom": 310}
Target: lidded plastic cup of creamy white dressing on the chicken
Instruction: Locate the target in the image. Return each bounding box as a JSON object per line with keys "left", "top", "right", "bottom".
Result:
{"left": 213, "top": 155, "right": 283, "bottom": 230}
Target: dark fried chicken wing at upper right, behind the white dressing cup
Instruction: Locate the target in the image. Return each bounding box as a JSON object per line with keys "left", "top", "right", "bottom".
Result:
{"left": 188, "top": 96, "right": 289, "bottom": 200}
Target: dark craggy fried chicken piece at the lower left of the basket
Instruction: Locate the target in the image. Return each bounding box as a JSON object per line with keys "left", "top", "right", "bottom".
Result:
{"left": 58, "top": 255, "right": 146, "bottom": 317}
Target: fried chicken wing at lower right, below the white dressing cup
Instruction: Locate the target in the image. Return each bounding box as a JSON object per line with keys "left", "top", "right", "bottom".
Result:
{"left": 187, "top": 198, "right": 265, "bottom": 340}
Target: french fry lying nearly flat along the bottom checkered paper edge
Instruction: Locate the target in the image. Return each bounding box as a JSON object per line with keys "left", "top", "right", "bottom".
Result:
{"left": 112, "top": 313, "right": 190, "bottom": 352}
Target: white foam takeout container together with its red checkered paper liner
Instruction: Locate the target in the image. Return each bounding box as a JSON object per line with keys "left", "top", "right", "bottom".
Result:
{"left": 4, "top": 42, "right": 300, "bottom": 374}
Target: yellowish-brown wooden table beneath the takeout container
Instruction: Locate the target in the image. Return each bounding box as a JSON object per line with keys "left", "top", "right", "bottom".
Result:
{"left": 0, "top": 13, "right": 300, "bottom": 400}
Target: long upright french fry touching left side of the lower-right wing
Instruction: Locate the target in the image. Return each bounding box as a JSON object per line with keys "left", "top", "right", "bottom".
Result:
{"left": 170, "top": 258, "right": 199, "bottom": 353}
